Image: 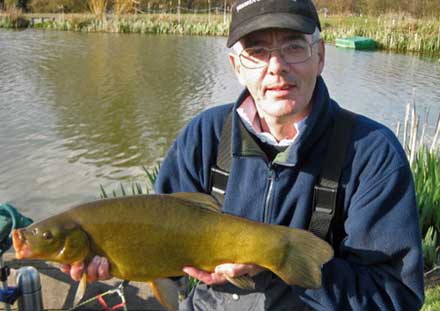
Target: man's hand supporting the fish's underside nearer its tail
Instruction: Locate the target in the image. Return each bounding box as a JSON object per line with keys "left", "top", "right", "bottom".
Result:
{"left": 183, "top": 263, "right": 264, "bottom": 285}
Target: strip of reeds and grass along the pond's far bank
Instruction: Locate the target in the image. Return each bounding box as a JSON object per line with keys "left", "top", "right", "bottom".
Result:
{"left": 0, "top": 0, "right": 440, "bottom": 56}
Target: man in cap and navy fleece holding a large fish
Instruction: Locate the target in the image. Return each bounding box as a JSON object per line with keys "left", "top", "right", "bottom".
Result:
{"left": 62, "top": 0, "right": 424, "bottom": 311}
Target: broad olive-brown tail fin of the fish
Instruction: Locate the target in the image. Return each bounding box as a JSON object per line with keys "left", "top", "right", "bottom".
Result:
{"left": 269, "top": 228, "right": 333, "bottom": 288}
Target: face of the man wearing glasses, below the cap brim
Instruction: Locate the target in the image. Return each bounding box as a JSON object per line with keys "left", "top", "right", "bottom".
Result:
{"left": 229, "top": 29, "right": 325, "bottom": 122}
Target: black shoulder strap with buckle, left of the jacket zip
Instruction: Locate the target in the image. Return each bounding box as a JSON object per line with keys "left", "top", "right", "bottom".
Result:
{"left": 210, "top": 110, "right": 232, "bottom": 204}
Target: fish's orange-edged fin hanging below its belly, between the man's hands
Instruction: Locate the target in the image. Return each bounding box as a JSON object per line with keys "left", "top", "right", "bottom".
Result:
{"left": 148, "top": 279, "right": 179, "bottom": 311}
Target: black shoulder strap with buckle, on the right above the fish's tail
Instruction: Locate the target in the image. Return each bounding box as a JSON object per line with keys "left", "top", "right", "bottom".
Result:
{"left": 309, "top": 109, "right": 356, "bottom": 244}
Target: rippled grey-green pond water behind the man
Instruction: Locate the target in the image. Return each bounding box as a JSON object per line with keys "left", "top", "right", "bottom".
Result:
{"left": 0, "top": 30, "right": 440, "bottom": 219}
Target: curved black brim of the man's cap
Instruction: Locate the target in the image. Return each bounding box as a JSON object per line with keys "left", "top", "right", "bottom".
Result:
{"left": 226, "top": 13, "right": 316, "bottom": 48}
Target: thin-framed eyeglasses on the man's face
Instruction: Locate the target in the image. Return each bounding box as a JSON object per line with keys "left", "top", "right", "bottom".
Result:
{"left": 238, "top": 39, "right": 320, "bottom": 69}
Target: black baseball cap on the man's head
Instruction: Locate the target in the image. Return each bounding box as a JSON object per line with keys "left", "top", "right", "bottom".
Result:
{"left": 226, "top": 0, "right": 321, "bottom": 48}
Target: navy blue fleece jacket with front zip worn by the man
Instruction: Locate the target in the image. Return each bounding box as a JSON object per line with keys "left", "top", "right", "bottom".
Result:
{"left": 156, "top": 77, "right": 424, "bottom": 311}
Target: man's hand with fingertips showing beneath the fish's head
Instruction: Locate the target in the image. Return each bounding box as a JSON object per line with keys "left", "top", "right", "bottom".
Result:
{"left": 60, "top": 256, "right": 112, "bottom": 282}
